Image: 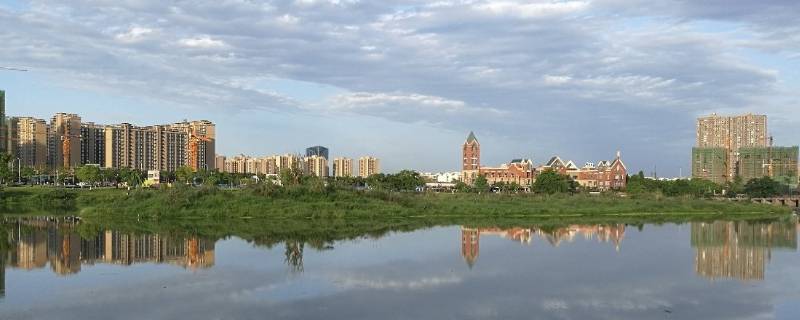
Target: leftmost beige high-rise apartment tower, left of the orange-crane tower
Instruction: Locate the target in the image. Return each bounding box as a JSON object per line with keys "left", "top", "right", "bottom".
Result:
{"left": 9, "top": 117, "right": 48, "bottom": 170}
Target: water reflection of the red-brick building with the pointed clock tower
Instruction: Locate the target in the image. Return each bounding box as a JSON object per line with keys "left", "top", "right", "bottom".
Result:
{"left": 461, "top": 224, "right": 625, "bottom": 268}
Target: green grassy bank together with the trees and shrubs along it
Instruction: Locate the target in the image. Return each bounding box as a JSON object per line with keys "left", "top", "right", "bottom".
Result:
{"left": 0, "top": 171, "right": 791, "bottom": 221}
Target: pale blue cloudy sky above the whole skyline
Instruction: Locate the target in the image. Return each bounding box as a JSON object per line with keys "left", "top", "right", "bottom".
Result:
{"left": 0, "top": 0, "right": 800, "bottom": 176}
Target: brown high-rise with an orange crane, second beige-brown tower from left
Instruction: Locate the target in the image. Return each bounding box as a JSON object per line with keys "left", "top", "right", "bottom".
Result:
{"left": 48, "top": 113, "right": 81, "bottom": 169}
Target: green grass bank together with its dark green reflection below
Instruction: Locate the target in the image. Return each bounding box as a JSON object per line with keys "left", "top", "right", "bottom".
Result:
{"left": 0, "top": 188, "right": 791, "bottom": 246}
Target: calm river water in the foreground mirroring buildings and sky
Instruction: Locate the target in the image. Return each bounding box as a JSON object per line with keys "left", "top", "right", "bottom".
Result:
{"left": 0, "top": 219, "right": 800, "bottom": 319}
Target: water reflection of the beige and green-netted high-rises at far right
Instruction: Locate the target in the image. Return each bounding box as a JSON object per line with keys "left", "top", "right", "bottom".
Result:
{"left": 691, "top": 221, "right": 797, "bottom": 281}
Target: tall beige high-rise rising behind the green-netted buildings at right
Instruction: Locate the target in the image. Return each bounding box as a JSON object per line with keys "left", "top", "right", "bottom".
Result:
{"left": 692, "top": 114, "right": 768, "bottom": 181}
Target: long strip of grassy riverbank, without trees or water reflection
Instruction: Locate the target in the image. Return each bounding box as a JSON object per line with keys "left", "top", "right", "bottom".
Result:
{"left": 0, "top": 187, "right": 791, "bottom": 220}
